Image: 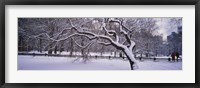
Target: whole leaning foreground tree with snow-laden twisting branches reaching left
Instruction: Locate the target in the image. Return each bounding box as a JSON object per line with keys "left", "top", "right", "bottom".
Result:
{"left": 25, "top": 18, "right": 138, "bottom": 70}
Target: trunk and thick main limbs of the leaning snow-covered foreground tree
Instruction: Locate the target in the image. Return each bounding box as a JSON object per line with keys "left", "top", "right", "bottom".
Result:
{"left": 70, "top": 18, "right": 138, "bottom": 70}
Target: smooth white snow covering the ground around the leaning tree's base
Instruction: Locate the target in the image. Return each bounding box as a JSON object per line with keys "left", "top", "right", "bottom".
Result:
{"left": 18, "top": 55, "right": 182, "bottom": 70}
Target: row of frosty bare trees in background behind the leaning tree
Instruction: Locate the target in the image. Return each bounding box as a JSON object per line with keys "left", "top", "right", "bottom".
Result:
{"left": 18, "top": 18, "right": 182, "bottom": 57}
